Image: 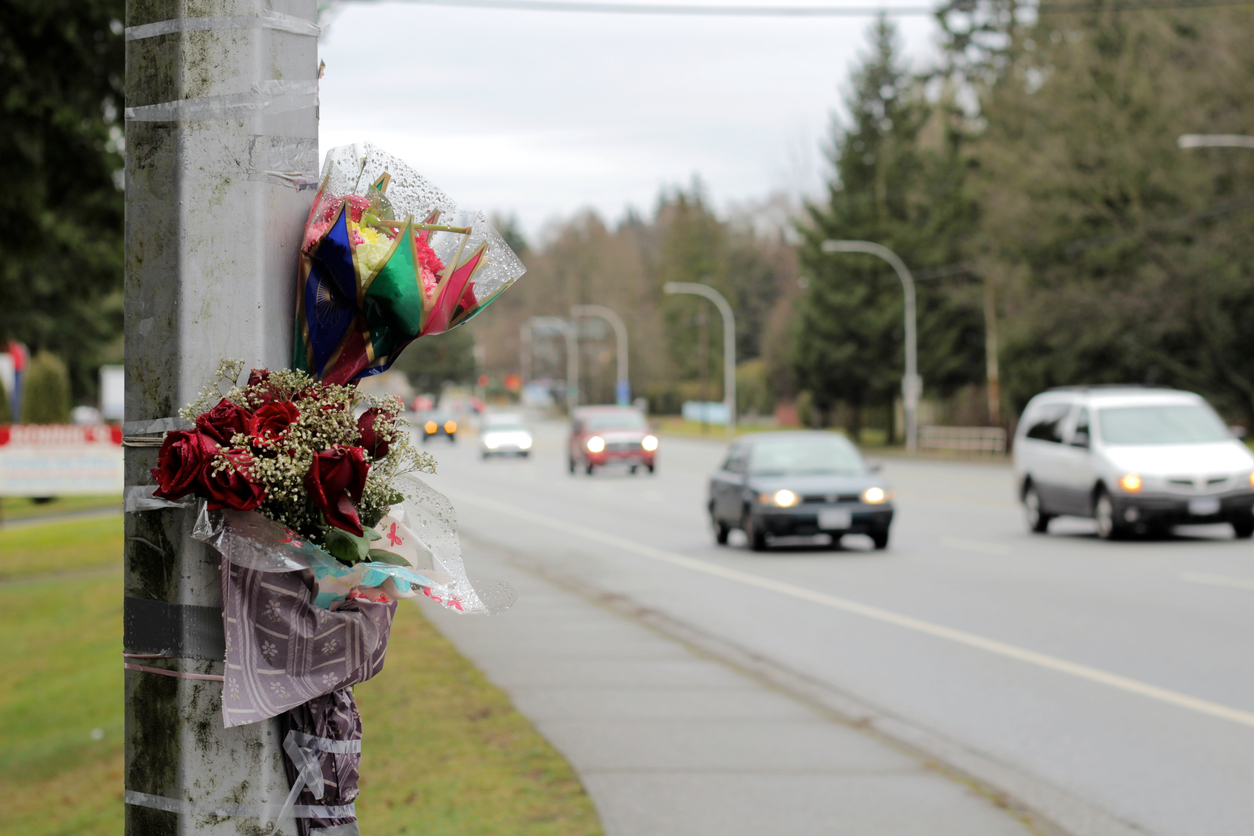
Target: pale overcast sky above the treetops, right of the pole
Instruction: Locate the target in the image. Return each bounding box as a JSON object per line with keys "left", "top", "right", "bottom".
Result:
{"left": 320, "top": 0, "right": 935, "bottom": 239}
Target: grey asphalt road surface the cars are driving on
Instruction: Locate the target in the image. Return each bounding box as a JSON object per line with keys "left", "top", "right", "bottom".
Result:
{"left": 416, "top": 422, "right": 1254, "bottom": 836}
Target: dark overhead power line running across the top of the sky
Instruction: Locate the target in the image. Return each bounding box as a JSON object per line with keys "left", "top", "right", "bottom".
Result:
{"left": 373, "top": 0, "right": 1254, "bottom": 18}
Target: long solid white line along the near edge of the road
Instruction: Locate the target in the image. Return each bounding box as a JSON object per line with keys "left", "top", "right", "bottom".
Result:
{"left": 441, "top": 488, "right": 1254, "bottom": 728}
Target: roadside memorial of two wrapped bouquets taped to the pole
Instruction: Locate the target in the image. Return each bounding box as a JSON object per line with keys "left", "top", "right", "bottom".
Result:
{"left": 134, "top": 145, "right": 524, "bottom": 836}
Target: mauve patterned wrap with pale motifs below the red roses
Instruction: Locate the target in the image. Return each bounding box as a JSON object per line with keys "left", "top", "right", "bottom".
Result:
{"left": 221, "top": 558, "right": 396, "bottom": 728}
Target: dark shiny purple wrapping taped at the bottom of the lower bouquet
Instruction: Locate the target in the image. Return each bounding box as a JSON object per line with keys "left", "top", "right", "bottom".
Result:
{"left": 280, "top": 688, "right": 361, "bottom": 836}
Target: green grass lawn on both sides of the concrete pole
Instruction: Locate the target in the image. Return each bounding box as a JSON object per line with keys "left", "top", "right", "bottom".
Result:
{"left": 0, "top": 516, "right": 601, "bottom": 836}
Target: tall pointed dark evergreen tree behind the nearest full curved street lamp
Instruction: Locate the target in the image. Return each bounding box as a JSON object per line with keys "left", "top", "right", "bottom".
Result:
{"left": 790, "top": 18, "right": 983, "bottom": 432}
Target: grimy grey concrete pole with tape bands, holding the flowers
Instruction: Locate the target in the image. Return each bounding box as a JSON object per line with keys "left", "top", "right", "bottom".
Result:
{"left": 123, "top": 0, "right": 319, "bottom": 836}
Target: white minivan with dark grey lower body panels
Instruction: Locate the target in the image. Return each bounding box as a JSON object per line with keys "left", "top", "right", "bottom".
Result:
{"left": 1014, "top": 386, "right": 1254, "bottom": 539}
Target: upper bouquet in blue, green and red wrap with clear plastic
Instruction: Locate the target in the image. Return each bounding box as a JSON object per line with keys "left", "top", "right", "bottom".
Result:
{"left": 295, "top": 144, "right": 525, "bottom": 384}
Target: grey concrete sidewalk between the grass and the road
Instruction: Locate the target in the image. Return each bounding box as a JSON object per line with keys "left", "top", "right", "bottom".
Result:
{"left": 424, "top": 544, "right": 1037, "bottom": 836}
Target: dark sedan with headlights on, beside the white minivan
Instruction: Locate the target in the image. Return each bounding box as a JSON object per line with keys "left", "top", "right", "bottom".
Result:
{"left": 707, "top": 431, "right": 893, "bottom": 551}
